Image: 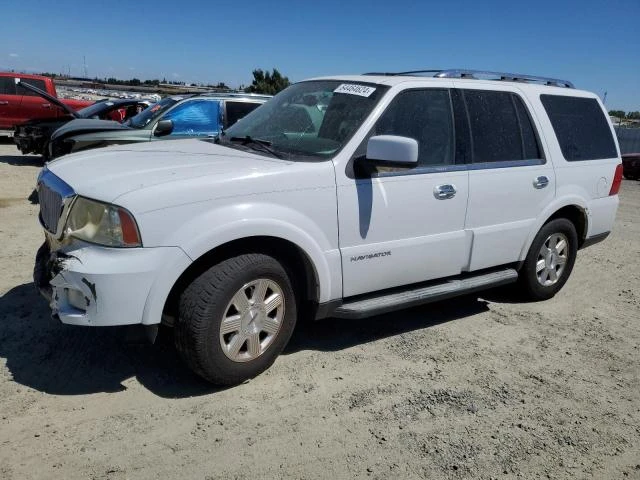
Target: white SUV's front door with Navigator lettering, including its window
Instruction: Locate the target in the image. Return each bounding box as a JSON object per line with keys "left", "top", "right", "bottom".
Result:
{"left": 337, "top": 88, "right": 469, "bottom": 297}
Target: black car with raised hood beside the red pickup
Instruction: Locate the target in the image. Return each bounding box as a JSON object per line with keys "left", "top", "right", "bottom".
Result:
{"left": 13, "top": 83, "right": 151, "bottom": 160}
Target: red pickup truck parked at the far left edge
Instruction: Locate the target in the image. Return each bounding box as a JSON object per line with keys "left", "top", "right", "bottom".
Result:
{"left": 0, "top": 72, "right": 93, "bottom": 135}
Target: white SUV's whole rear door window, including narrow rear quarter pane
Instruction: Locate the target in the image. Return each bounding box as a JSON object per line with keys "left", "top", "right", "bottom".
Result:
{"left": 464, "top": 90, "right": 542, "bottom": 163}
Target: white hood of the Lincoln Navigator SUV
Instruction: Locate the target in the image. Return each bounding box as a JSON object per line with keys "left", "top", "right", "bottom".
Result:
{"left": 47, "top": 140, "right": 312, "bottom": 208}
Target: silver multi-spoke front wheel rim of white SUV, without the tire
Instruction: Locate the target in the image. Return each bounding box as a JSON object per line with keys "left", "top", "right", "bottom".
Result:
{"left": 220, "top": 278, "right": 284, "bottom": 362}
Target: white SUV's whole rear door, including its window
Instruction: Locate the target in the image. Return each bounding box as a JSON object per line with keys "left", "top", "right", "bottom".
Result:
{"left": 457, "top": 85, "right": 556, "bottom": 271}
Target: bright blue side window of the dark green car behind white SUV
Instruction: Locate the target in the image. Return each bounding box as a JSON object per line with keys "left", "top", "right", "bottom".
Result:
{"left": 162, "top": 100, "right": 220, "bottom": 136}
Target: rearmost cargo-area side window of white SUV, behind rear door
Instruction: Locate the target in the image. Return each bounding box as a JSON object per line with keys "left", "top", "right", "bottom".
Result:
{"left": 540, "top": 95, "right": 618, "bottom": 162}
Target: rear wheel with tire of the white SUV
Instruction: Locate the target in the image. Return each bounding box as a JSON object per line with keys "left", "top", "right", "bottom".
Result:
{"left": 519, "top": 218, "right": 578, "bottom": 301}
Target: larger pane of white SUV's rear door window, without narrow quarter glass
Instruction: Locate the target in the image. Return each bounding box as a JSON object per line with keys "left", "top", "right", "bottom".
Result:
{"left": 464, "top": 90, "right": 523, "bottom": 163}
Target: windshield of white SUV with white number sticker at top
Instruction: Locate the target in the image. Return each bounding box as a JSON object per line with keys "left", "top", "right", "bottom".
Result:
{"left": 219, "top": 80, "right": 388, "bottom": 159}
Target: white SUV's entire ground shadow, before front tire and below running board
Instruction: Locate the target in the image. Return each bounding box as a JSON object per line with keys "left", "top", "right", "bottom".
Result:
{"left": 0, "top": 283, "right": 488, "bottom": 398}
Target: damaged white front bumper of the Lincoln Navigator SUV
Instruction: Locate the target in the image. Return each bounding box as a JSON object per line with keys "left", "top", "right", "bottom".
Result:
{"left": 34, "top": 242, "right": 187, "bottom": 326}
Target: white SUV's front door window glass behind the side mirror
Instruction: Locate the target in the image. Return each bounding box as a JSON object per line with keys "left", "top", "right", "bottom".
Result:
{"left": 373, "top": 89, "right": 455, "bottom": 165}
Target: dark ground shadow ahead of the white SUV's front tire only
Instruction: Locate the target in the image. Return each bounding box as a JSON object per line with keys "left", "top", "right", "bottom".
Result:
{"left": 0, "top": 283, "right": 220, "bottom": 398}
